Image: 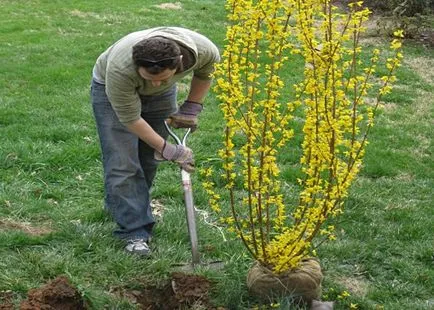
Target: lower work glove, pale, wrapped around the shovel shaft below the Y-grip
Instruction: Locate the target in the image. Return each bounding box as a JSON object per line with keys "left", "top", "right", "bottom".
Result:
{"left": 154, "top": 141, "right": 194, "bottom": 173}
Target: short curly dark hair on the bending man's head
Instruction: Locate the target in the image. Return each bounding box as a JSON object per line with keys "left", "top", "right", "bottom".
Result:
{"left": 133, "top": 36, "right": 182, "bottom": 74}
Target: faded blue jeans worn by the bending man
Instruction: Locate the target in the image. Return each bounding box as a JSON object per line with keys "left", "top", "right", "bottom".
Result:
{"left": 91, "top": 81, "right": 176, "bottom": 240}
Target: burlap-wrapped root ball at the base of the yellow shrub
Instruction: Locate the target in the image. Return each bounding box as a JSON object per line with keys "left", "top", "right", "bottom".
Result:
{"left": 247, "top": 259, "right": 323, "bottom": 304}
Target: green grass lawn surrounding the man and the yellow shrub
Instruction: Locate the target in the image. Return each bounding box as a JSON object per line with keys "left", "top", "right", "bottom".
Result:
{"left": 0, "top": 0, "right": 434, "bottom": 309}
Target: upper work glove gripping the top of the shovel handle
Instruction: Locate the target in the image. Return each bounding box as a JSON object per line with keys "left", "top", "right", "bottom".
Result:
{"left": 168, "top": 100, "right": 203, "bottom": 131}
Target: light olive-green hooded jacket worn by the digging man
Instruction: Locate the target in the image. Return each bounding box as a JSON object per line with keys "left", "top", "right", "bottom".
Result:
{"left": 93, "top": 27, "right": 220, "bottom": 123}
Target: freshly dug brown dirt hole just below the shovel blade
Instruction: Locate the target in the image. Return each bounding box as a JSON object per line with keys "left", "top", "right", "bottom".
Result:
{"left": 114, "top": 272, "right": 224, "bottom": 310}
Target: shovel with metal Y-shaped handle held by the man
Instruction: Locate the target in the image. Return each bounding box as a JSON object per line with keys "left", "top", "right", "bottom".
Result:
{"left": 164, "top": 122, "right": 223, "bottom": 270}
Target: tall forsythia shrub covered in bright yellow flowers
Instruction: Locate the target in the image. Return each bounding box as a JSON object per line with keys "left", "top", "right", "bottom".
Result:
{"left": 204, "top": 0, "right": 402, "bottom": 273}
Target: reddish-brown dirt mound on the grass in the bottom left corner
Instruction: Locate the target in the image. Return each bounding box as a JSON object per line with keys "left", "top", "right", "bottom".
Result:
{"left": 20, "top": 276, "right": 88, "bottom": 310}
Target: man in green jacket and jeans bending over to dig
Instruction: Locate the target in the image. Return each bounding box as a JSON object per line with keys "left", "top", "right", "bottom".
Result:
{"left": 91, "top": 27, "right": 220, "bottom": 256}
